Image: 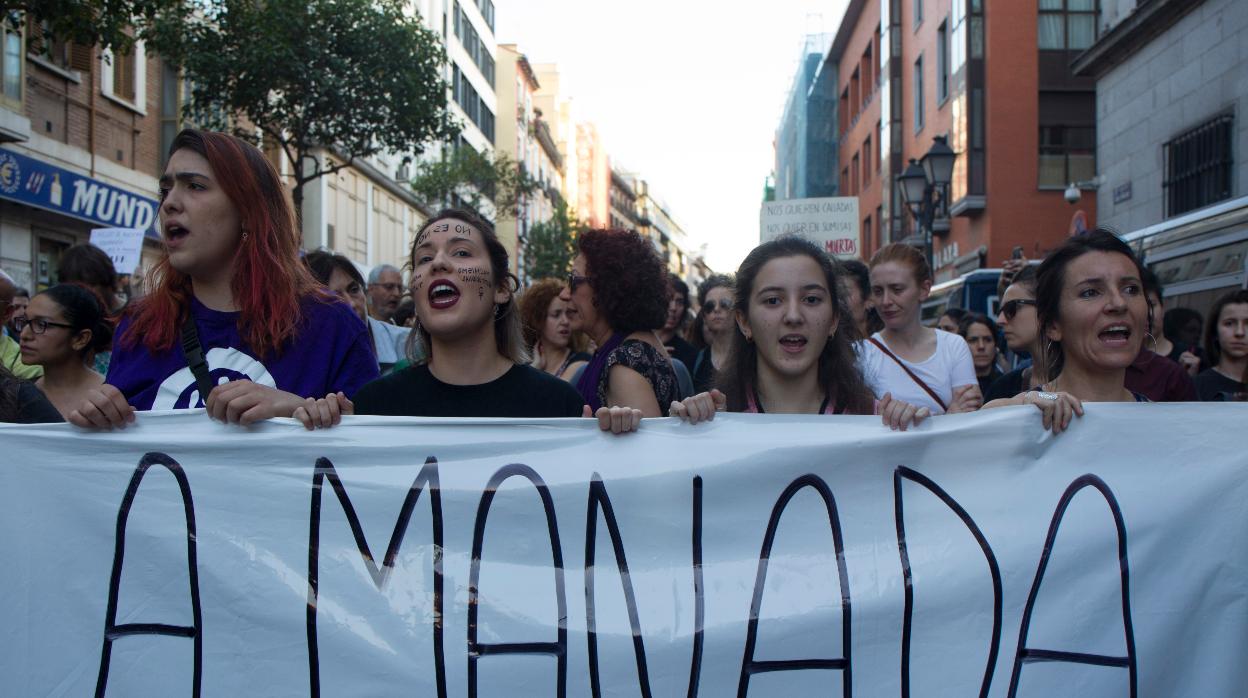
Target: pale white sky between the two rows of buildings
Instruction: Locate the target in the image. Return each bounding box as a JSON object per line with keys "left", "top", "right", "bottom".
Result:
{"left": 495, "top": 0, "right": 845, "bottom": 271}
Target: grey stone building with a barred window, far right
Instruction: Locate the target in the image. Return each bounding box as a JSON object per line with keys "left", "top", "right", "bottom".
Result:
{"left": 1075, "top": 0, "right": 1248, "bottom": 313}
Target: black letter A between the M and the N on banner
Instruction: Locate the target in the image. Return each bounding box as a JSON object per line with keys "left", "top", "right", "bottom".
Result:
{"left": 468, "top": 463, "right": 568, "bottom": 698}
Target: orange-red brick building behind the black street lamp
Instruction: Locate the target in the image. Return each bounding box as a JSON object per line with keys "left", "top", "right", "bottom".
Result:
{"left": 818, "top": 0, "right": 1097, "bottom": 281}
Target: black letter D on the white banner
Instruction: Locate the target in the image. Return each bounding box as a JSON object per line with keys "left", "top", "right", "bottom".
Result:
{"left": 892, "top": 466, "right": 1002, "bottom": 698}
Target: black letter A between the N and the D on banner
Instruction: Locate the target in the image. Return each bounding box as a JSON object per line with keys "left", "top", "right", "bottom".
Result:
{"left": 736, "top": 473, "right": 852, "bottom": 698}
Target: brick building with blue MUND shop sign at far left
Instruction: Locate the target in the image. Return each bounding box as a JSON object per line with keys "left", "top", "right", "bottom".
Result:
{"left": 0, "top": 21, "right": 167, "bottom": 291}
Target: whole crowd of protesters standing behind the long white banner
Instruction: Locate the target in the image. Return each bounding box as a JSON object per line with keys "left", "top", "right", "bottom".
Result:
{"left": 0, "top": 130, "right": 1248, "bottom": 433}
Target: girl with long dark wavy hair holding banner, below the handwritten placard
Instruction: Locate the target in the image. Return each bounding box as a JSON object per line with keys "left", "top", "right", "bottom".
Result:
{"left": 671, "top": 237, "right": 930, "bottom": 430}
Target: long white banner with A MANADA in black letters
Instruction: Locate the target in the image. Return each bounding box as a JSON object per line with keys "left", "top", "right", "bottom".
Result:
{"left": 0, "top": 403, "right": 1248, "bottom": 698}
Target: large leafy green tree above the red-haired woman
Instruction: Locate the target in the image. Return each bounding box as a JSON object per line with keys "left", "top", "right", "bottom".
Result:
{"left": 154, "top": 0, "right": 459, "bottom": 210}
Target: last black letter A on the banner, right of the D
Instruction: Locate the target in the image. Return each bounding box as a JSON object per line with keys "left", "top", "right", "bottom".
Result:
{"left": 1010, "top": 474, "right": 1136, "bottom": 698}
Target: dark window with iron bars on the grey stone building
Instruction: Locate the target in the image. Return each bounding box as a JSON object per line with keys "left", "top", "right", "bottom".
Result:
{"left": 1162, "top": 114, "right": 1234, "bottom": 216}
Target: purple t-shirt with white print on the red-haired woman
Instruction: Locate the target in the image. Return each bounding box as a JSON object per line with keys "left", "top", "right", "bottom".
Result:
{"left": 107, "top": 297, "right": 378, "bottom": 410}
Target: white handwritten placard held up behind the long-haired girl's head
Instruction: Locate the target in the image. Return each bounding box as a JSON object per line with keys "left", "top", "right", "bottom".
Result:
{"left": 759, "top": 196, "right": 861, "bottom": 258}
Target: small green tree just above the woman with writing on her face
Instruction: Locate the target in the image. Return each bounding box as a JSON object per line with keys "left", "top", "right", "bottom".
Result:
{"left": 411, "top": 146, "right": 540, "bottom": 220}
